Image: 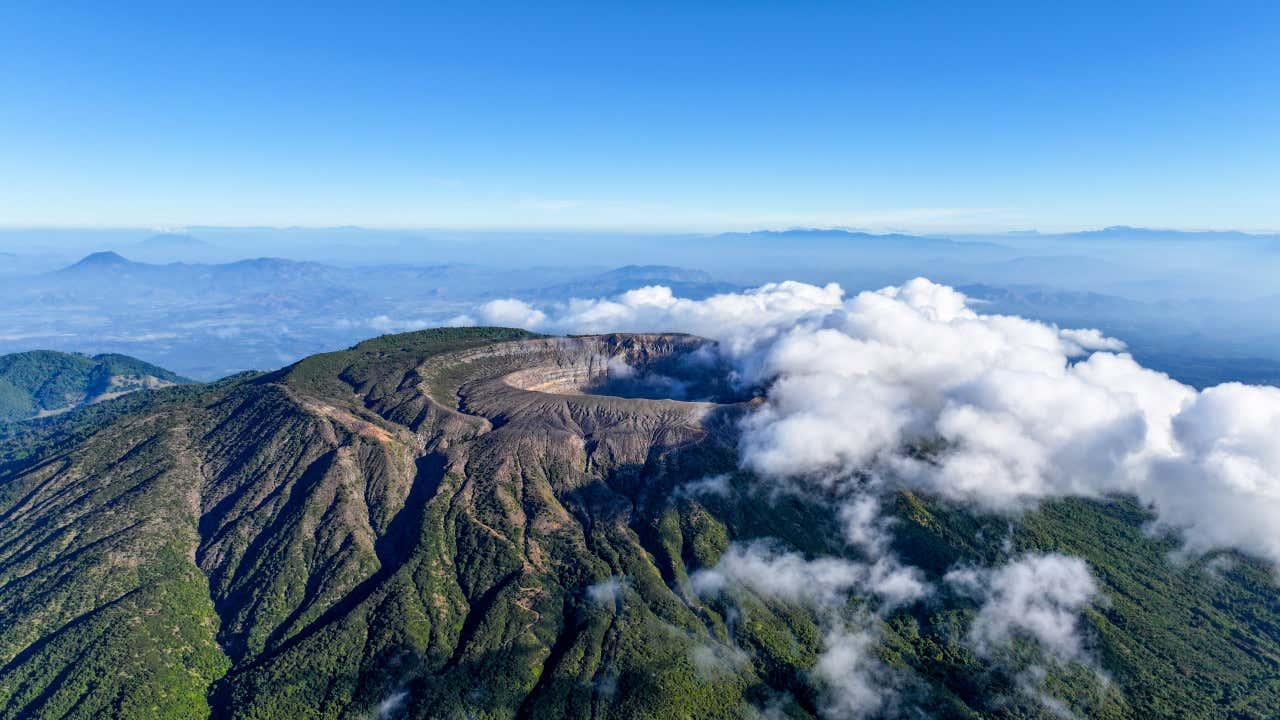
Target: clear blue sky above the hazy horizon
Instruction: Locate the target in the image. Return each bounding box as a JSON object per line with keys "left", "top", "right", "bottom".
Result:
{"left": 0, "top": 0, "right": 1280, "bottom": 231}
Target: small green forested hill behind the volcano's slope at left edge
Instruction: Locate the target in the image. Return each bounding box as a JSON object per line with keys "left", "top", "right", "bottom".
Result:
{"left": 0, "top": 350, "right": 192, "bottom": 421}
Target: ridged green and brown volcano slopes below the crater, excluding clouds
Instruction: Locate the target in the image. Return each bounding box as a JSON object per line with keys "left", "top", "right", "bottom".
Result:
{"left": 0, "top": 328, "right": 1280, "bottom": 720}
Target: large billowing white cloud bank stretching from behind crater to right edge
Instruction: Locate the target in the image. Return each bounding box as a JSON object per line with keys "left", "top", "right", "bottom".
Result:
{"left": 481, "top": 278, "right": 1280, "bottom": 562}
